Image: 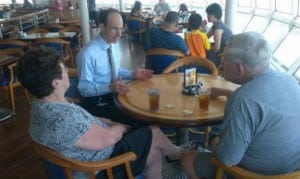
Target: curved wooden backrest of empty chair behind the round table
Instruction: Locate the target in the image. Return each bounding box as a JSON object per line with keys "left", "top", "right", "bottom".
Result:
{"left": 163, "top": 57, "right": 218, "bottom": 76}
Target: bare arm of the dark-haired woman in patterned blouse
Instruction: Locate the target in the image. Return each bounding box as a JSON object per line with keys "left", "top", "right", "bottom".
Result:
{"left": 75, "top": 123, "right": 129, "bottom": 150}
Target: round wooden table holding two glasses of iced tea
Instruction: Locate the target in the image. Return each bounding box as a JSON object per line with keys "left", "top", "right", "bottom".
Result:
{"left": 116, "top": 73, "right": 238, "bottom": 141}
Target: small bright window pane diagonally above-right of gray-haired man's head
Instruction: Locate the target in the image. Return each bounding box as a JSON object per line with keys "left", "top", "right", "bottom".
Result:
{"left": 264, "top": 20, "right": 289, "bottom": 51}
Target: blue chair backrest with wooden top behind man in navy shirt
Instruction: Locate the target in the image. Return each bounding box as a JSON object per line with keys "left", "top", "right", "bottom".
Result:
{"left": 145, "top": 48, "right": 185, "bottom": 74}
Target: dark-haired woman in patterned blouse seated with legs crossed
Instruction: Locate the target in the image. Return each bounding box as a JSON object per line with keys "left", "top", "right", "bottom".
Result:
{"left": 17, "top": 48, "right": 182, "bottom": 179}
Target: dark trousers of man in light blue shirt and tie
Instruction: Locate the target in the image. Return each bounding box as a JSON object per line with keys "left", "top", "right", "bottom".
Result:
{"left": 81, "top": 94, "right": 145, "bottom": 128}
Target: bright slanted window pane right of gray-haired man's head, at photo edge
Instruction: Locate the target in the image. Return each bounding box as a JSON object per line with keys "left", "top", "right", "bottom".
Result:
{"left": 273, "top": 27, "right": 300, "bottom": 69}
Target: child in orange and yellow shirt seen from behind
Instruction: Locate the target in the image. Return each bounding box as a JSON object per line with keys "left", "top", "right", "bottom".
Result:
{"left": 185, "top": 13, "right": 210, "bottom": 58}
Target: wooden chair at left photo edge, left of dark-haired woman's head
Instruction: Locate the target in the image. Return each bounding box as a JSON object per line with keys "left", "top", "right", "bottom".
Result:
{"left": 0, "top": 48, "right": 31, "bottom": 114}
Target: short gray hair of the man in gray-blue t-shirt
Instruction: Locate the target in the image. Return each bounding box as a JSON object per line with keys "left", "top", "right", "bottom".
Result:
{"left": 224, "top": 32, "right": 272, "bottom": 68}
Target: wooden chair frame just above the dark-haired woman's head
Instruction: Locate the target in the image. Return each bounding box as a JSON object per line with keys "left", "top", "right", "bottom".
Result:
{"left": 35, "top": 38, "right": 75, "bottom": 67}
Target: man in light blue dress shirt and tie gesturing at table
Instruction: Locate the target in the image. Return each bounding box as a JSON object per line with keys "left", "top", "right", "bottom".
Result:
{"left": 76, "top": 9, "right": 153, "bottom": 126}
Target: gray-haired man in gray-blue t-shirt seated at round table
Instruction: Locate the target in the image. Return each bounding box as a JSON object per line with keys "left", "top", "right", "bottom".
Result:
{"left": 182, "top": 32, "right": 300, "bottom": 178}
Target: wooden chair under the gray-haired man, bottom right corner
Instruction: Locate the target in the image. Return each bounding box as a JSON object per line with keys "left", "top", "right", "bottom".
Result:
{"left": 210, "top": 157, "right": 300, "bottom": 179}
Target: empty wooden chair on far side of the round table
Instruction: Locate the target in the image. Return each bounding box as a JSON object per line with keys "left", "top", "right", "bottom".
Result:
{"left": 163, "top": 56, "right": 218, "bottom": 147}
